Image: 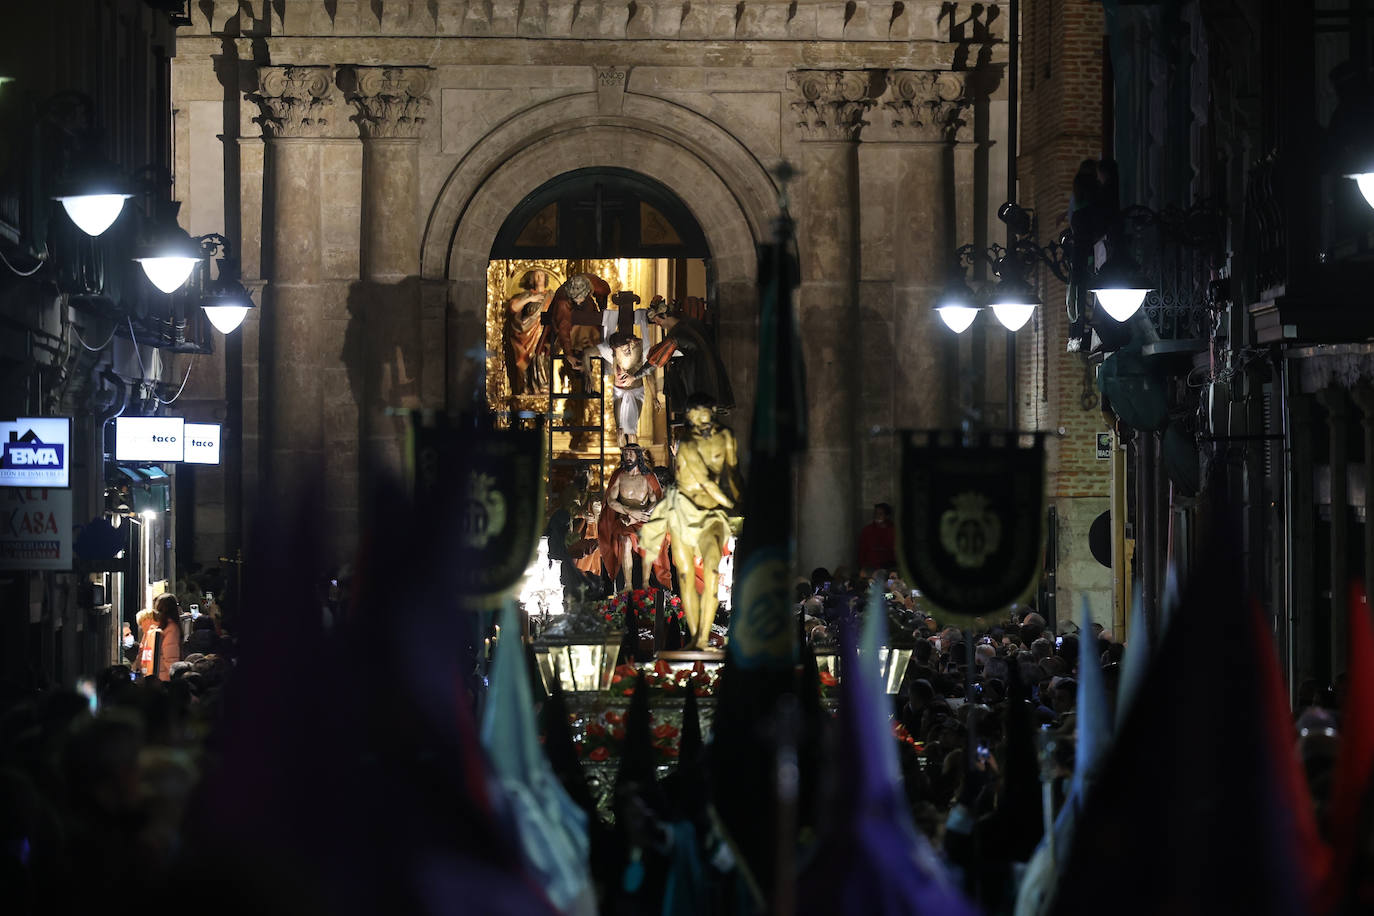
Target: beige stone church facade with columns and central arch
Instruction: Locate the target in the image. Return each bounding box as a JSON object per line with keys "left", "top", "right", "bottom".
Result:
{"left": 172, "top": 0, "right": 1109, "bottom": 617}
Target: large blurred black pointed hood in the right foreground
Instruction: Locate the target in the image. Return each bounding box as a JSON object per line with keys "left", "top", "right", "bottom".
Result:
{"left": 1054, "top": 516, "right": 1315, "bottom": 916}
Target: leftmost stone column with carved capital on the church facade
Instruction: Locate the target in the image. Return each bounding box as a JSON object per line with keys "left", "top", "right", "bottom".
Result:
{"left": 254, "top": 67, "right": 334, "bottom": 507}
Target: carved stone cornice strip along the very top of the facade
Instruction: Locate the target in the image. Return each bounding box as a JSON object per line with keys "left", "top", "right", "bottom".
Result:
{"left": 181, "top": 0, "right": 1004, "bottom": 41}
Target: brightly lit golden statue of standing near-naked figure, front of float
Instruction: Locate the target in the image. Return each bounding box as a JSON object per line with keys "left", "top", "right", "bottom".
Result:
{"left": 639, "top": 394, "right": 741, "bottom": 650}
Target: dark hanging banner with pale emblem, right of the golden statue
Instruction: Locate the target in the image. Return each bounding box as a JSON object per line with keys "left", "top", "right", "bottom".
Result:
{"left": 897, "top": 431, "right": 1046, "bottom": 625}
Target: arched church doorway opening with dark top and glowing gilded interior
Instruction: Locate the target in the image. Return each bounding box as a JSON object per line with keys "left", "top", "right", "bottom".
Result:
{"left": 485, "top": 166, "right": 719, "bottom": 493}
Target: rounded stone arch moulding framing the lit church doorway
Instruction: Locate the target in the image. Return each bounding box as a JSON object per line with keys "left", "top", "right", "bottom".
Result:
{"left": 420, "top": 93, "right": 776, "bottom": 431}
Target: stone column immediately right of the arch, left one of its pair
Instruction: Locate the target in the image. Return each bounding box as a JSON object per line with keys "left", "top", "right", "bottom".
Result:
{"left": 789, "top": 70, "right": 883, "bottom": 571}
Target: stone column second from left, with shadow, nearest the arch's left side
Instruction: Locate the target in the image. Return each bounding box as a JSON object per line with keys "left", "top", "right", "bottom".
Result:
{"left": 339, "top": 67, "right": 430, "bottom": 490}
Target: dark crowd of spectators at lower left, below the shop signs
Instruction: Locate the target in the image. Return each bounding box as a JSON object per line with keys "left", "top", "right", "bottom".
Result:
{"left": 0, "top": 595, "right": 234, "bottom": 913}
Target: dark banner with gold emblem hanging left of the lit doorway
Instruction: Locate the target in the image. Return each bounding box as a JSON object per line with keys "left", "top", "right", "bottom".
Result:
{"left": 412, "top": 417, "right": 545, "bottom": 610}
